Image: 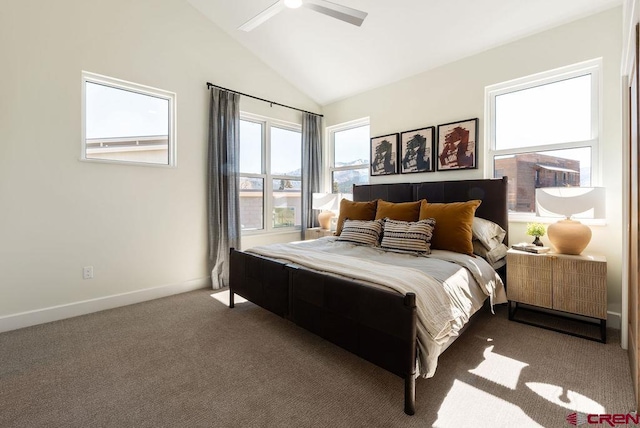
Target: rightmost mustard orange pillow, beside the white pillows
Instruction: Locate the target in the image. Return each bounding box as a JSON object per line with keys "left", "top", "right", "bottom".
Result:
{"left": 420, "top": 200, "right": 482, "bottom": 255}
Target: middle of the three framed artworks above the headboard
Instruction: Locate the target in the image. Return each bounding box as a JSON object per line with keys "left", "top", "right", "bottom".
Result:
{"left": 400, "top": 126, "right": 435, "bottom": 174}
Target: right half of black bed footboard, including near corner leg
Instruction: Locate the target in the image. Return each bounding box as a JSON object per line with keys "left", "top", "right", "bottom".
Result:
{"left": 289, "top": 266, "right": 417, "bottom": 415}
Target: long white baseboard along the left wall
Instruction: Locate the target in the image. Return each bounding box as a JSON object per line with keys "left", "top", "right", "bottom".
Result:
{"left": 0, "top": 277, "right": 211, "bottom": 333}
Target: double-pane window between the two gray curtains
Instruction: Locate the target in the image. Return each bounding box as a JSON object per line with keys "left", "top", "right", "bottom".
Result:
{"left": 240, "top": 113, "right": 302, "bottom": 233}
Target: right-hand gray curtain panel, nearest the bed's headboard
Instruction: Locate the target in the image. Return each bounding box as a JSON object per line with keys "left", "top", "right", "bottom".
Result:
{"left": 302, "top": 113, "right": 322, "bottom": 239}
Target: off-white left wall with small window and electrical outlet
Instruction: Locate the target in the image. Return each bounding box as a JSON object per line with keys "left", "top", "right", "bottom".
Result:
{"left": 0, "top": 0, "right": 320, "bottom": 331}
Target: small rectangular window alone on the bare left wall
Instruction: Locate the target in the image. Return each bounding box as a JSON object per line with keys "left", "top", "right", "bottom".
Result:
{"left": 81, "top": 72, "right": 176, "bottom": 166}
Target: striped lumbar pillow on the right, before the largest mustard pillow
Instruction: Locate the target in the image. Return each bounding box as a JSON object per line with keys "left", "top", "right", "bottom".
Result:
{"left": 381, "top": 218, "right": 436, "bottom": 254}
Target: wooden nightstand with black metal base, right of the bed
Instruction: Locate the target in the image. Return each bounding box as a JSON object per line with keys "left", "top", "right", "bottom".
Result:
{"left": 507, "top": 249, "right": 607, "bottom": 343}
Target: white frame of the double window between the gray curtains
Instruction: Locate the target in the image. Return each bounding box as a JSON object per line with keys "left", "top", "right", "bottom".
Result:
{"left": 238, "top": 111, "right": 303, "bottom": 236}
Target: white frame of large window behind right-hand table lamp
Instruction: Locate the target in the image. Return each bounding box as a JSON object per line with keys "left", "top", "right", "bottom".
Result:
{"left": 484, "top": 58, "right": 602, "bottom": 222}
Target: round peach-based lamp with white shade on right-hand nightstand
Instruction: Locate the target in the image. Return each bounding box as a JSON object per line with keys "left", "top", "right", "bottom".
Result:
{"left": 536, "top": 187, "right": 605, "bottom": 255}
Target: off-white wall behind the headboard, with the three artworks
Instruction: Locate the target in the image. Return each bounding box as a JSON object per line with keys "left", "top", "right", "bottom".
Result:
{"left": 324, "top": 7, "right": 623, "bottom": 312}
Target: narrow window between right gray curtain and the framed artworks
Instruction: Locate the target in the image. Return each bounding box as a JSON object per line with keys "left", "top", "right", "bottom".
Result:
{"left": 328, "top": 119, "right": 370, "bottom": 193}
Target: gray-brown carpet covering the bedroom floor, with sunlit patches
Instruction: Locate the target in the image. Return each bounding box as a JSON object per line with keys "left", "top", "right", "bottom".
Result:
{"left": 0, "top": 290, "right": 635, "bottom": 427}
